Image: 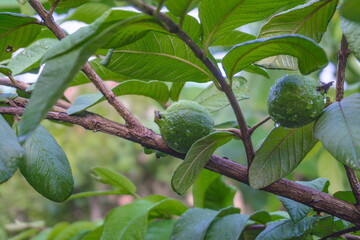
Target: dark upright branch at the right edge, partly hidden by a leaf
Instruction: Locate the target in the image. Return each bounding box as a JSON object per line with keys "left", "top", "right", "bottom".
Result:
{"left": 336, "top": 34, "right": 360, "bottom": 205}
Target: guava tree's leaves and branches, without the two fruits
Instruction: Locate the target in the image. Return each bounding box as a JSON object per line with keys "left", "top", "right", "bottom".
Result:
{"left": 0, "top": 0, "right": 360, "bottom": 240}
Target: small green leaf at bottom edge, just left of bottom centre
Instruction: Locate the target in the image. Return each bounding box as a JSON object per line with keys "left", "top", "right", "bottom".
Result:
{"left": 145, "top": 219, "right": 175, "bottom": 240}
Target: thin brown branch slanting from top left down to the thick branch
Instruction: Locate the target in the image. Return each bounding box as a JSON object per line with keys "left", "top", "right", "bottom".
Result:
{"left": 29, "top": 0, "right": 144, "bottom": 129}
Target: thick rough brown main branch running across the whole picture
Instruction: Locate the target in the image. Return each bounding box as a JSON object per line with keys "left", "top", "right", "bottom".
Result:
{"left": 0, "top": 106, "right": 360, "bottom": 226}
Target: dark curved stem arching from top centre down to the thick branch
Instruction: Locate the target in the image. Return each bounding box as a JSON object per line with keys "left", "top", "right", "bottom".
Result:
{"left": 127, "top": 0, "right": 255, "bottom": 165}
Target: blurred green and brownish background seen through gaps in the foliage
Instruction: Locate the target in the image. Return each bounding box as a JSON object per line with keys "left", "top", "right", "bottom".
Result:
{"left": 0, "top": 2, "right": 359, "bottom": 239}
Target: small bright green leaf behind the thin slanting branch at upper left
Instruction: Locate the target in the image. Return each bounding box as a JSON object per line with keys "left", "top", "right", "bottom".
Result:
{"left": 69, "top": 58, "right": 129, "bottom": 87}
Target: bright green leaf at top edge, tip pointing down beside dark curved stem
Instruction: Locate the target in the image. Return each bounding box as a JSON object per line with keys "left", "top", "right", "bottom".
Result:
{"left": 199, "top": 0, "right": 303, "bottom": 51}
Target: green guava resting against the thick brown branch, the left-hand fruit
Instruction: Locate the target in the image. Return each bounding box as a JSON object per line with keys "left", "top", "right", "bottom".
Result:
{"left": 155, "top": 100, "right": 214, "bottom": 153}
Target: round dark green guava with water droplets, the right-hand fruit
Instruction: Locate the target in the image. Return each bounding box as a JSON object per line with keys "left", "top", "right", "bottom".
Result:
{"left": 267, "top": 74, "right": 325, "bottom": 128}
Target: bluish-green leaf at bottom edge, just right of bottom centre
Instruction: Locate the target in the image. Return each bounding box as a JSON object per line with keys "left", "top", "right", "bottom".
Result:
{"left": 205, "top": 214, "right": 249, "bottom": 240}
